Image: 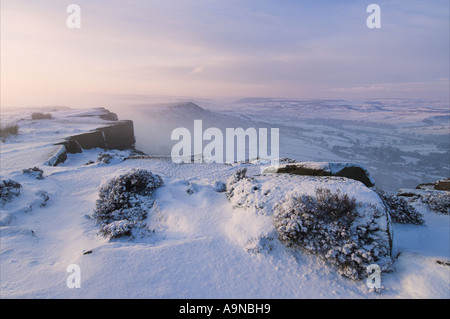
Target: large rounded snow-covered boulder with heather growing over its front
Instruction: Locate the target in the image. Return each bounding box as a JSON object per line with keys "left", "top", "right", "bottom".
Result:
{"left": 226, "top": 169, "right": 392, "bottom": 280}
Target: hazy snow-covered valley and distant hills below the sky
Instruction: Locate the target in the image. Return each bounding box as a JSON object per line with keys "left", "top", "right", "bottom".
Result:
{"left": 108, "top": 98, "right": 450, "bottom": 193}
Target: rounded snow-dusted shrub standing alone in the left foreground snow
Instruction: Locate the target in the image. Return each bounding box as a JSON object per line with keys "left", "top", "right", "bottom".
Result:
{"left": 94, "top": 169, "right": 163, "bottom": 238}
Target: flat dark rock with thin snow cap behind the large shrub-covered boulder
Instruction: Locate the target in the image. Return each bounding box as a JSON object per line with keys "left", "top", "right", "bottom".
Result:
{"left": 263, "top": 162, "right": 375, "bottom": 187}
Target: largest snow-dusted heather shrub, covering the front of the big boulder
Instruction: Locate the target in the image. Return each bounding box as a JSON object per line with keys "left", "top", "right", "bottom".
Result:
{"left": 273, "top": 188, "right": 390, "bottom": 280}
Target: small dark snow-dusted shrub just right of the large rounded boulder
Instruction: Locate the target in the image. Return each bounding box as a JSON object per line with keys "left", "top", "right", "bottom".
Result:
{"left": 375, "top": 189, "right": 425, "bottom": 225}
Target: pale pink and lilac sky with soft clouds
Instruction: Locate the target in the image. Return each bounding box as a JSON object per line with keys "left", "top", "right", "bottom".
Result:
{"left": 1, "top": 0, "right": 450, "bottom": 107}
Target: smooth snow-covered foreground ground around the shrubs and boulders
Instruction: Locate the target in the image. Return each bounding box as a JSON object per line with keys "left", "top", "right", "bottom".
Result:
{"left": 0, "top": 105, "right": 450, "bottom": 299}
